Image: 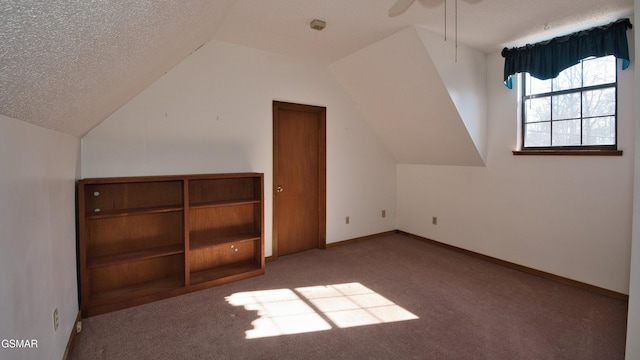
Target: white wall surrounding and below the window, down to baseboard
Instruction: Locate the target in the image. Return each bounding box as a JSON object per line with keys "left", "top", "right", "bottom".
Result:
{"left": 397, "top": 53, "right": 635, "bottom": 293}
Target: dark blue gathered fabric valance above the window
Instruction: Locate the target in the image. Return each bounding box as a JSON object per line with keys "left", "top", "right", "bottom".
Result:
{"left": 502, "top": 19, "right": 632, "bottom": 89}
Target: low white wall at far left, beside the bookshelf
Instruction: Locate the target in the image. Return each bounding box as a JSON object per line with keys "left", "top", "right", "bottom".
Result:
{"left": 0, "top": 115, "right": 80, "bottom": 360}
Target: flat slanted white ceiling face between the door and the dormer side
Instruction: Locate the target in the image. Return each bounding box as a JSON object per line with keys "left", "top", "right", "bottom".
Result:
{"left": 331, "top": 27, "right": 486, "bottom": 166}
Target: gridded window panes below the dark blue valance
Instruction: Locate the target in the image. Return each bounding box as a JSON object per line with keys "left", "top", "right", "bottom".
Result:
{"left": 522, "top": 56, "right": 617, "bottom": 150}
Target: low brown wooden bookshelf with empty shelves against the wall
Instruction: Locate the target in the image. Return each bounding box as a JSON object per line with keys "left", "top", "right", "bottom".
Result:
{"left": 77, "top": 173, "right": 264, "bottom": 317}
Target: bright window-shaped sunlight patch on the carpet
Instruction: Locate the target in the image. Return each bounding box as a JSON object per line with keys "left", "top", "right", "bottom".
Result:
{"left": 226, "top": 283, "right": 418, "bottom": 339}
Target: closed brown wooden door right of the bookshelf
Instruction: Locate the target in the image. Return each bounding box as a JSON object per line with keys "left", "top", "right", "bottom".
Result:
{"left": 273, "top": 101, "right": 326, "bottom": 258}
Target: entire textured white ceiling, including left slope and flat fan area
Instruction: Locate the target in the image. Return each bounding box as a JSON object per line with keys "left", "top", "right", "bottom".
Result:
{"left": 0, "top": 0, "right": 633, "bottom": 136}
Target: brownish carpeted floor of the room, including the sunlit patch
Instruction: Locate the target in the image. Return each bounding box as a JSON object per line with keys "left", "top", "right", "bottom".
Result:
{"left": 71, "top": 234, "right": 627, "bottom": 360}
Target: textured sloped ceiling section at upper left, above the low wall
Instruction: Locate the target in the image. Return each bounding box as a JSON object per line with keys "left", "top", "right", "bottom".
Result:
{"left": 0, "top": 0, "right": 235, "bottom": 136}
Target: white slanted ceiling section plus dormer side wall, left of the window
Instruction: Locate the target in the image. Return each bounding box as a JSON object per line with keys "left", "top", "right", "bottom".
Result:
{"left": 330, "top": 26, "right": 486, "bottom": 165}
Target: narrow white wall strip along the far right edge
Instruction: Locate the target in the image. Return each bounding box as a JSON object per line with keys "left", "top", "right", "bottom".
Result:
{"left": 625, "top": 0, "right": 640, "bottom": 360}
